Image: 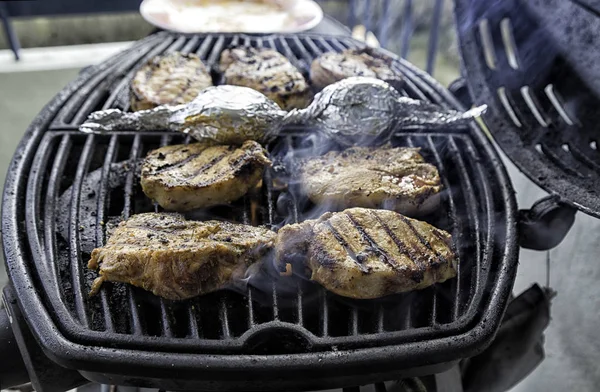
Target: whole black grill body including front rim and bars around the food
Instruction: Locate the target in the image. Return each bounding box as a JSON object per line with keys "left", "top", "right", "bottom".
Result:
{"left": 2, "top": 33, "right": 518, "bottom": 391}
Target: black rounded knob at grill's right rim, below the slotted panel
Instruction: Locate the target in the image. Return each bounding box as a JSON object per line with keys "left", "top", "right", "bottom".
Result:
{"left": 519, "top": 196, "right": 577, "bottom": 250}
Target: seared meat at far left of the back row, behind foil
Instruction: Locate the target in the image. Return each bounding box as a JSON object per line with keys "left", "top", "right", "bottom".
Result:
{"left": 131, "top": 52, "right": 212, "bottom": 111}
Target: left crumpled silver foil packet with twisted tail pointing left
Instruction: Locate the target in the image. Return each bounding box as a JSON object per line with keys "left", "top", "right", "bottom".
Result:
{"left": 79, "top": 86, "right": 287, "bottom": 144}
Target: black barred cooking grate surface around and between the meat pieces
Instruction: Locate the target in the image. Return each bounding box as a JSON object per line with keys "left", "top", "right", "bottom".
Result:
{"left": 5, "top": 33, "right": 516, "bottom": 370}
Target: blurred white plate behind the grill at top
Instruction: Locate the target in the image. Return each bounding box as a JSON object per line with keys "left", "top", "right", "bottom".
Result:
{"left": 140, "top": 0, "right": 323, "bottom": 33}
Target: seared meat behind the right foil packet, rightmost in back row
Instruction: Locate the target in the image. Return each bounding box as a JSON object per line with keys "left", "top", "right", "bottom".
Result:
{"left": 310, "top": 48, "right": 402, "bottom": 89}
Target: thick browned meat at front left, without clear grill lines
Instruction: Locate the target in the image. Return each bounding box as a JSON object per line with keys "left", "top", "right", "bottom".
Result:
{"left": 88, "top": 213, "right": 275, "bottom": 300}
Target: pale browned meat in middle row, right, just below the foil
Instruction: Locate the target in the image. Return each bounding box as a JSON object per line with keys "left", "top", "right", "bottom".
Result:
{"left": 299, "top": 147, "right": 442, "bottom": 216}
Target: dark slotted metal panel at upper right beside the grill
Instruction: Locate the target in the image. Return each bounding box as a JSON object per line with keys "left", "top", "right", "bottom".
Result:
{"left": 455, "top": 0, "right": 600, "bottom": 217}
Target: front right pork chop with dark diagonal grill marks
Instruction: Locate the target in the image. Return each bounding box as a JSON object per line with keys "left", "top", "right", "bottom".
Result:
{"left": 276, "top": 208, "right": 457, "bottom": 299}
